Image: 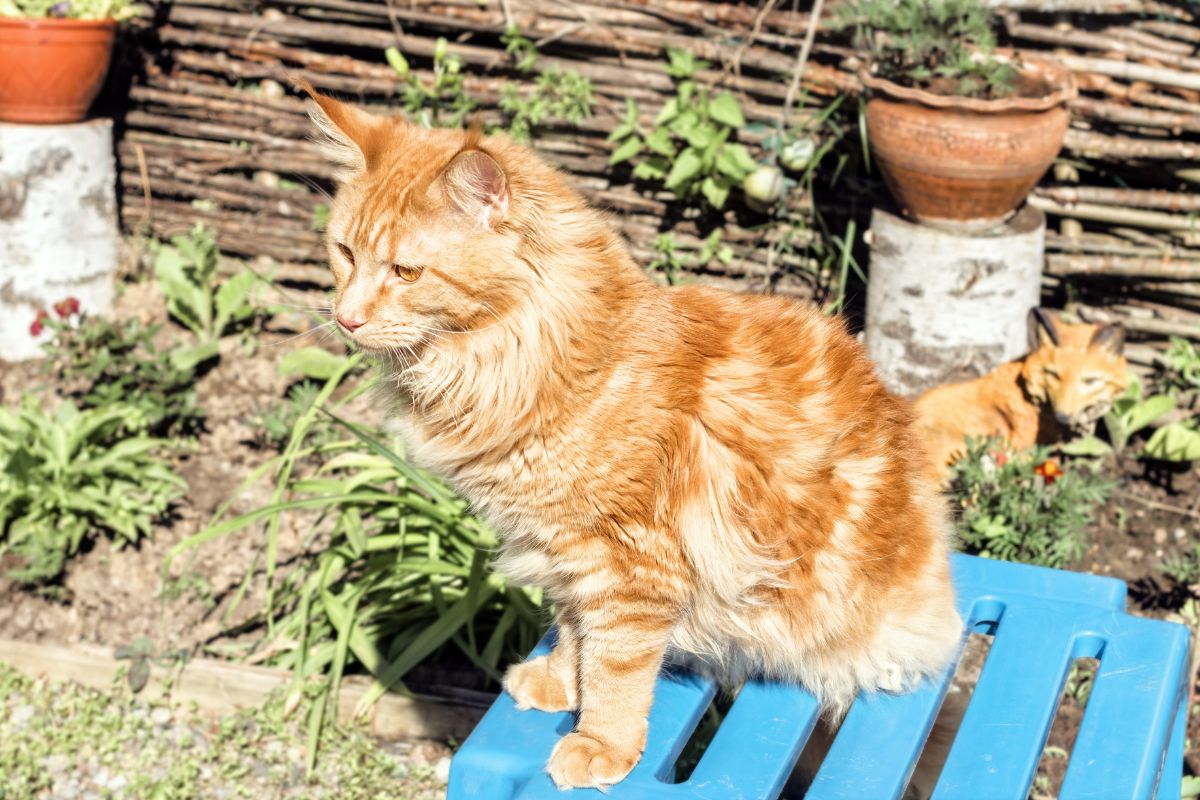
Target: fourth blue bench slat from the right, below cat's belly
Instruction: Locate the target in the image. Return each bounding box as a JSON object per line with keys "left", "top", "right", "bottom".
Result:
{"left": 688, "top": 681, "right": 817, "bottom": 800}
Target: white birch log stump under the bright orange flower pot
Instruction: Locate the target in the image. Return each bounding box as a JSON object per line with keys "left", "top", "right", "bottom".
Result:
{"left": 0, "top": 120, "right": 119, "bottom": 361}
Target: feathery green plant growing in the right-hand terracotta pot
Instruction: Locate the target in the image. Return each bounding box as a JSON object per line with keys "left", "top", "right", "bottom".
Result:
{"left": 834, "top": 0, "right": 1018, "bottom": 97}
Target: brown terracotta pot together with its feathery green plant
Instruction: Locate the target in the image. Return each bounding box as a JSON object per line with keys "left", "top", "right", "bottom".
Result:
{"left": 838, "top": 0, "right": 1076, "bottom": 228}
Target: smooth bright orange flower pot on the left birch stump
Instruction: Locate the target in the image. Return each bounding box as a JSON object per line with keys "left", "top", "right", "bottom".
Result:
{"left": 0, "top": 18, "right": 116, "bottom": 124}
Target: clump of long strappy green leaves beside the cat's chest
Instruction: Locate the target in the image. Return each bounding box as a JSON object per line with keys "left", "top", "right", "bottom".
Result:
{"left": 164, "top": 356, "right": 544, "bottom": 724}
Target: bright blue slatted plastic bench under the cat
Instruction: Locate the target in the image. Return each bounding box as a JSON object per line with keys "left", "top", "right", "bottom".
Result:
{"left": 448, "top": 555, "right": 1188, "bottom": 800}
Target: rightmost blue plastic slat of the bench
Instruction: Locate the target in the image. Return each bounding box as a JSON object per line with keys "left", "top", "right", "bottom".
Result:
{"left": 1060, "top": 614, "right": 1188, "bottom": 800}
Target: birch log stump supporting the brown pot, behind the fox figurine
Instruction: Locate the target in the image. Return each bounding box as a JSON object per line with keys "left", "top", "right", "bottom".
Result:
{"left": 865, "top": 205, "right": 1045, "bottom": 397}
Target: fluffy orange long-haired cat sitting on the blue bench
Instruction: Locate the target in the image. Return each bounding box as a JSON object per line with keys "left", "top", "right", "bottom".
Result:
{"left": 310, "top": 90, "right": 961, "bottom": 787}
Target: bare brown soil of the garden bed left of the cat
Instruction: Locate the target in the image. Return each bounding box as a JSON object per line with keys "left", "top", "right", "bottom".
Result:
{"left": 0, "top": 282, "right": 364, "bottom": 666}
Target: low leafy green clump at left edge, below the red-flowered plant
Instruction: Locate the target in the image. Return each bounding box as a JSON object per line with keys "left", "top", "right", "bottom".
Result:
{"left": 0, "top": 395, "right": 186, "bottom": 584}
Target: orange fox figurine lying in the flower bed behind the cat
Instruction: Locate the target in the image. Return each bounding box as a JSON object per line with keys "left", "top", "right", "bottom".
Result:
{"left": 917, "top": 311, "right": 1129, "bottom": 479}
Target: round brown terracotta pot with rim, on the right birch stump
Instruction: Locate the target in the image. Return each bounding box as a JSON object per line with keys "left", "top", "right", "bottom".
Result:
{"left": 862, "top": 59, "right": 1078, "bottom": 229}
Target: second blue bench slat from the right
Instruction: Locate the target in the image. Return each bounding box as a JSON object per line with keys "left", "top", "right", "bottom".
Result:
{"left": 934, "top": 609, "right": 1074, "bottom": 800}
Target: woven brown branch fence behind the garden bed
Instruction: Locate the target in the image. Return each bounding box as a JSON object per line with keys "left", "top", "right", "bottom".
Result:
{"left": 112, "top": 0, "right": 1200, "bottom": 363}
